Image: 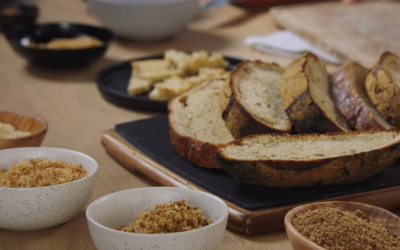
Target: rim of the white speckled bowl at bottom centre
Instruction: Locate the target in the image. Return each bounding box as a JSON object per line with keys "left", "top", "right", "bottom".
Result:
{"left": 86, "top": 187, "right": 229, "bottom": 238}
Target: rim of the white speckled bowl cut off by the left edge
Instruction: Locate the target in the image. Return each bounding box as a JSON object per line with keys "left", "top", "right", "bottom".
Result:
{"left": 0, "top": 147, "right": 99, "bottom": 192}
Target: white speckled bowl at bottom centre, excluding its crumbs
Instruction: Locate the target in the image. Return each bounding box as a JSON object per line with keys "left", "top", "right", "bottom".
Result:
{"left": 86, "top": 187, "right": 228, "bottom": 250}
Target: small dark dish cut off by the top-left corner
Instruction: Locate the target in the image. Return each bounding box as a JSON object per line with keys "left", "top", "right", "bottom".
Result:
{"left": 0, "top": 1, "right": 39, "bottom": 32}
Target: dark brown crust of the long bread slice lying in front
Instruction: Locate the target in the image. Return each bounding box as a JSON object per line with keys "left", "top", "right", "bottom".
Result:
{"left": 217, "top": 132, "right": 400, "bottom": 188}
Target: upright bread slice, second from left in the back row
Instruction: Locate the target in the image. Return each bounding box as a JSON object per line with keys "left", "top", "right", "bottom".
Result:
{"left": 222, "top": 61, "right": 291, "bottom": 138}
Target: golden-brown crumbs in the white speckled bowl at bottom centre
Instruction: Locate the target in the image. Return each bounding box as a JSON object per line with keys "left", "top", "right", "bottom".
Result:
{"left": 120, "top": 200, "right": 211, "bottom": 234}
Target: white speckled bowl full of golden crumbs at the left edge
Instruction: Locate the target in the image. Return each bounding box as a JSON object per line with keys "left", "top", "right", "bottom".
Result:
{"left": 0, "top": 148, "right": 98, "bottom": 231}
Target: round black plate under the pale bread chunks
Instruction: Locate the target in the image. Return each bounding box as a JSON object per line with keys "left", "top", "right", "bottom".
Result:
{"left": 96, "top": 55, "right": 243, "bottom": 112}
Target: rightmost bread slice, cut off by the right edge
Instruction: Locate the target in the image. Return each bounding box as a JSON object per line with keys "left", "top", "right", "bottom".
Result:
{"left": 365, "top": 52, "right": 400, "bottom": 127}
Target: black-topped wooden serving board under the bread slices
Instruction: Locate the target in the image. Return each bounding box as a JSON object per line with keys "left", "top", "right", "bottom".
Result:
{"left": 101, "top": 115, "right": 400, "bottom": 235}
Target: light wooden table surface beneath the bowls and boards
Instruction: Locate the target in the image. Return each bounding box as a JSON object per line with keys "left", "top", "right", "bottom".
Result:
{"left": 0, "top": 0, "right": 396, "bottom": 250}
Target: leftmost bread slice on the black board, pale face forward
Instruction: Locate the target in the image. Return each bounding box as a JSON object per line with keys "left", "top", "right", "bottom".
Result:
{"left": 168, "top": 80, "right": 234, "bottom": 168}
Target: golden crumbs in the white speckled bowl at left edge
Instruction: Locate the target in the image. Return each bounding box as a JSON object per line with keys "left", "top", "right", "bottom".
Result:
{"left": 0, "top": 158, "right": 87, "bottom": 188}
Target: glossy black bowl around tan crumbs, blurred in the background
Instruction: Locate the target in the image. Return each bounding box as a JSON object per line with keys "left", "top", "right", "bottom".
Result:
{"left": 6, "top": 23, "right": 114, "bottom": 68}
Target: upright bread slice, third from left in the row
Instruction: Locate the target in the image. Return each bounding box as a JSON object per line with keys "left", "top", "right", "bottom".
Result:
{"left": 280, "top": 53, "right": 351, "bottom": 133}
